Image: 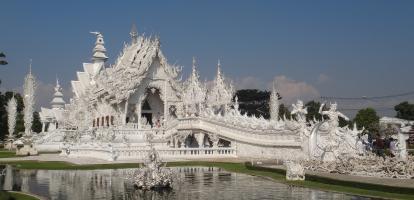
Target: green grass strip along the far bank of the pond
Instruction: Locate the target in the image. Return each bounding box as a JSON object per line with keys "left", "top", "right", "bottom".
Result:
{"left": 0, "top": 161, "right": 414, "bottom": 199}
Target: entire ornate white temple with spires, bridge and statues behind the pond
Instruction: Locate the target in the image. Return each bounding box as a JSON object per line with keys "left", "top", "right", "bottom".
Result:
{"left": 36, "top": 24, "right": 410, "bottom": 171}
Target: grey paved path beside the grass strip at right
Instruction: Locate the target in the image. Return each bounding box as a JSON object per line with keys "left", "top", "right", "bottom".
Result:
{"left": 261, "top": 165, "right": 414, "bottom": 189}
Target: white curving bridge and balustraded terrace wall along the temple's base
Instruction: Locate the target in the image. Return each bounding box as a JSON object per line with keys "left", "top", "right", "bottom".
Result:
{"left": 47, "top": 117, "right": 302, "bottom": 160}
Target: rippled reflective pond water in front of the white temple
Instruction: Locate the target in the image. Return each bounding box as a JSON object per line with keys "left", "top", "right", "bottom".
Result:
{"left": 0, "top": 166, "right": 374, "bottom": 200}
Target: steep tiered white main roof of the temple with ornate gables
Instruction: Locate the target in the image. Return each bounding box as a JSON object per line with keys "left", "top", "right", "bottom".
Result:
{"left": 72, "top": 29, "right": 181, "bottom": 103}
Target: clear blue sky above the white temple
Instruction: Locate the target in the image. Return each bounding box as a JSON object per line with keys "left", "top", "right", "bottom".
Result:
{"left": 0, "top": 0, "right": 414, "bottom": 115}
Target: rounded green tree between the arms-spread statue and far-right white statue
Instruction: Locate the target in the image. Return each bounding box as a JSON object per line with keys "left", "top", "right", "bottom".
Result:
{"left": 354, "top": 108, "right": 379, "bottom": 136}
